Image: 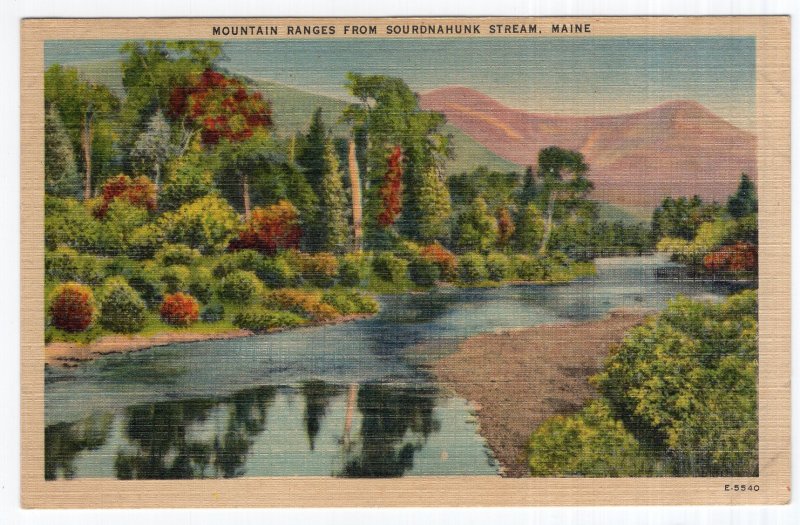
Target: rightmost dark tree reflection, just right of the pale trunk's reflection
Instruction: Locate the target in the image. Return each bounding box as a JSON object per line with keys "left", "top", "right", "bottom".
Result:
{"left": 341, "top": 384, "right": 440, "bottom": 477}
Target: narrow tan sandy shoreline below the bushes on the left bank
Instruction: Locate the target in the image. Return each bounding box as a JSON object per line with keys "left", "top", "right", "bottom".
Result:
{"left": 44, "top": 314, "right": 375, "bottom": 368}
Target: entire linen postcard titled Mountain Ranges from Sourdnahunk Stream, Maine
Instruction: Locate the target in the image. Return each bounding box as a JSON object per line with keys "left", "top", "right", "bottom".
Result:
{"left": 21, "top": 17, "right": 791, "bottom": 508}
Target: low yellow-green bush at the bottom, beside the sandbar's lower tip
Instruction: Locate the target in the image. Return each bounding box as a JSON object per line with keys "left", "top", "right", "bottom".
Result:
{"left": 528, "top": 401, "right": 653, "bottom": 478}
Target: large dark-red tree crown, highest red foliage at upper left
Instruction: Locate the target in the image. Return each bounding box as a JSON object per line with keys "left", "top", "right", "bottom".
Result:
{"left": 169, "top": 69, "right": 272, "bottom": 144}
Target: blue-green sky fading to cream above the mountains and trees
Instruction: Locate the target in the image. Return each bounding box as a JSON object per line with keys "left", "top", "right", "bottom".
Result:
{"left": 45, "top": 36, "right": 755, "bottom": 130}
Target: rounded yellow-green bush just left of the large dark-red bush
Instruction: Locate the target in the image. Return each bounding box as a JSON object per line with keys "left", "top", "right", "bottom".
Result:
{"left": 159, "top": 195, "right": 239, "bottom": 254}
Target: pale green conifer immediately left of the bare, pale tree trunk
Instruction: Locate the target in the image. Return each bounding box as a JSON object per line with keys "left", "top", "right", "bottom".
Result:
{"left": 315, "top": 139, "right": 348, "bottom": 253}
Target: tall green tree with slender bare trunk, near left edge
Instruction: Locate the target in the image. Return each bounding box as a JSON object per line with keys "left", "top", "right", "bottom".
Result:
{"left": 44, "top": 64, "right": 119, "bottom": 200}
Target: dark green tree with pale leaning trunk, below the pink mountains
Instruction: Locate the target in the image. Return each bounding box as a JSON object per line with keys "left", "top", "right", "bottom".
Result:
{"left": 538, "top": 146, "right": 593, "bottom": 253}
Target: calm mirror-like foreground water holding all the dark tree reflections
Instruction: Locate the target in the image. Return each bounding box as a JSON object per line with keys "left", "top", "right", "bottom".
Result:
{"left": 45, "top": 380, "right": 488, "bottom": 479}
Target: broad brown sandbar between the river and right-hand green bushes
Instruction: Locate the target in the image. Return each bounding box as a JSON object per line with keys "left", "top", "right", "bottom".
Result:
{"left": 432, "top": 310, "right": 653, "bottom": 477}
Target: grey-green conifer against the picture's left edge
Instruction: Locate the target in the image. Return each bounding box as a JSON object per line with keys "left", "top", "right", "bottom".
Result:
{"left": 44, "top": 106, "right": 81, "bottom": 197}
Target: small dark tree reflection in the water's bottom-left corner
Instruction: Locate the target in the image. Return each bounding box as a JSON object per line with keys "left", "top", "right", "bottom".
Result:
{"left": 44, "top": 414, "right": 114, "bottom": 479}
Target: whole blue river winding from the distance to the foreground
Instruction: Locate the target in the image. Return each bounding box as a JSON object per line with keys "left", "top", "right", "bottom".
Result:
{"left": 45, "top": 255, "right": 730, "bottom": 479}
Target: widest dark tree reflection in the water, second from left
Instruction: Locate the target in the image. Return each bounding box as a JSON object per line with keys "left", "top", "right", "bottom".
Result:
{"left": 114, "top": 387, "right": 275, "bottom": 479}
